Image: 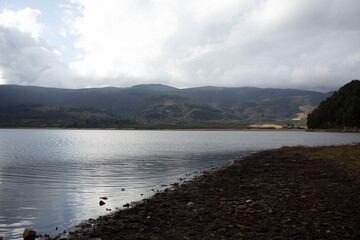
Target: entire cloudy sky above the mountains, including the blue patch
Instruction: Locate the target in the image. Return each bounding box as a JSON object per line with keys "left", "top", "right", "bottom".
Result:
{"left": 0, "top": 0, "right": 360, "bottom": 92}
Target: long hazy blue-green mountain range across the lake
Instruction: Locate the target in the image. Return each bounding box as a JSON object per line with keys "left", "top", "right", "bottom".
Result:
{"left": 0, "top": 84, "right": 331, "bottom": 127}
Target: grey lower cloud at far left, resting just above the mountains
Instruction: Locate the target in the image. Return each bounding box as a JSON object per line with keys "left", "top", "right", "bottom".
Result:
{"left": 0, "top": 27, "right": 80, "bottom": 87}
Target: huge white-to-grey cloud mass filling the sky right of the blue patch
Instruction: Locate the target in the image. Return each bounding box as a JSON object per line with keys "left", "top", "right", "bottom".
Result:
{"left": 64, "top": 0, "right": 360, "bottom": 88}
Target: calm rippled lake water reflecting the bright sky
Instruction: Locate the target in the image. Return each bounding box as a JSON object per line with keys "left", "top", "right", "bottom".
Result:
{"left": 0, "top": 129, "right": 360, "bottom": 239}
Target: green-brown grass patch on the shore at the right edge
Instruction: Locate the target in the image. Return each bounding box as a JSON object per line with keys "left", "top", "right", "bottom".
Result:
{"left": 310, "top": 144, "right": 360, "bottom": 171}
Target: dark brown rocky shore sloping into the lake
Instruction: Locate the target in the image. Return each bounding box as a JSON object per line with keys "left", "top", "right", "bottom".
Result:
{"left": 43, "top": 147, "right": 360, "bottom": 240}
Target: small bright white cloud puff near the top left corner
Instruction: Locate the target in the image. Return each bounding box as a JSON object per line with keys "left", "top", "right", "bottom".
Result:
{"left": 0, "top": 7, "right": 44, "bottom": 39}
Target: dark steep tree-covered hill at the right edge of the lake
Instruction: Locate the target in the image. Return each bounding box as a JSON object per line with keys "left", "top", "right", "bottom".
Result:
{"left": 307, "top": 80, "right": 360, "bottom": 129}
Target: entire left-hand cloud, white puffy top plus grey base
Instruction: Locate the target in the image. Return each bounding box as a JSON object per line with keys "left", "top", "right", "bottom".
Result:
{"left": 0, "top": 8, "right": 91, "bottom": 88}
